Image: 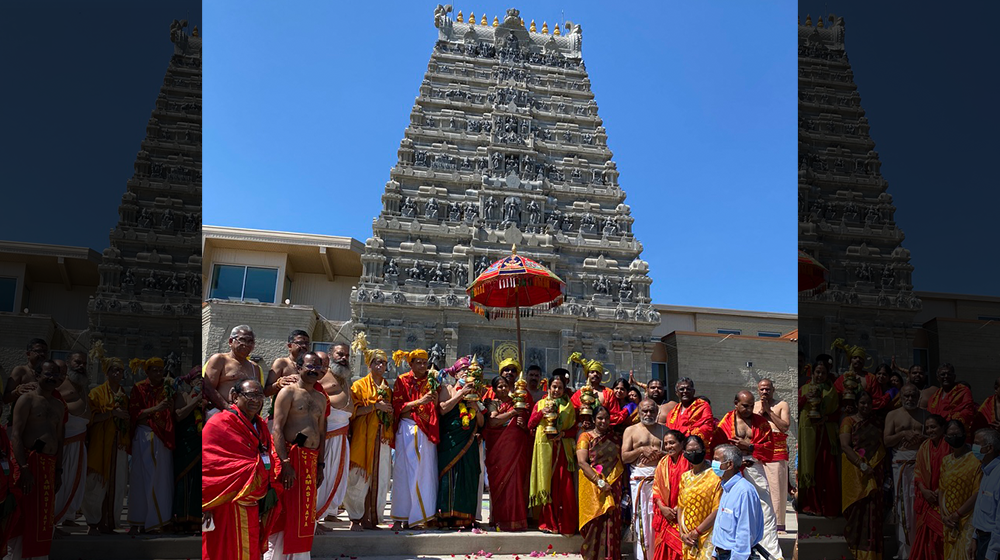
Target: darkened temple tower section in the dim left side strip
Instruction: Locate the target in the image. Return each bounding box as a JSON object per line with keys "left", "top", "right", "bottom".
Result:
{"left": 88, "top": 21, "right": 201, "bottom": 374}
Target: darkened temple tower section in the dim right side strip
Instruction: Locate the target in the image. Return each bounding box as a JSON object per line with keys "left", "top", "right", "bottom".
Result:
{"left": 799, "top": 16, "right": 921, "bottom": 364}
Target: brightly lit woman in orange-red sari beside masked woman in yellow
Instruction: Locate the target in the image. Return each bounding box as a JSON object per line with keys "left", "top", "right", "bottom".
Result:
{"left": 653, "top": 430, "right": 690, "bottom": 560}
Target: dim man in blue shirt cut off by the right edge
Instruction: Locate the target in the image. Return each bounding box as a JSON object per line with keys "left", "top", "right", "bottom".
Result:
{"left": 972, "top": 428, "right": 1000, "bottom": 560}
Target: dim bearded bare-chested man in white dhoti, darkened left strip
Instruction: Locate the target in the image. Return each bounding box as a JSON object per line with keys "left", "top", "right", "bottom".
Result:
{"left": 55, "top": 352, "right": 90, "bottom": 531}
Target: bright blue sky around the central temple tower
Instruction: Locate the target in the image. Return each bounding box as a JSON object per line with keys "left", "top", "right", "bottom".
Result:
{"left": 203, "top": 0, "right": 797, "bottom": 313}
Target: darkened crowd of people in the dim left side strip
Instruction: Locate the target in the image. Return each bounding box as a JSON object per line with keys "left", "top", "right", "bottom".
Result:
{"left": 0, "top": 338, "right": 201, "bottom": 559}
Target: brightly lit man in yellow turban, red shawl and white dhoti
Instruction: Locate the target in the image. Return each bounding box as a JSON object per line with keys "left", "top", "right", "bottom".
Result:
{"left": 391, "top": 349, "right": 440, "bottom": 531}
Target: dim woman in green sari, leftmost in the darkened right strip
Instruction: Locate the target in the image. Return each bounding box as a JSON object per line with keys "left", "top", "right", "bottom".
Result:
{"left": 797, "top": 361, "right": 840, "bottom": 517}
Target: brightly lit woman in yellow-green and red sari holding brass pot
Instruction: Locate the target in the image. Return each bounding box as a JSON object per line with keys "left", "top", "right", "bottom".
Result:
{"left": 528, "top": 373, "right": 579, "bottom": 535}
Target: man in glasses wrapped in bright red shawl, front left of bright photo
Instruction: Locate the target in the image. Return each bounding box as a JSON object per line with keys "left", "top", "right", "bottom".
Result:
{"left": 201, "top": 379, "right": 274, "bottom": 560}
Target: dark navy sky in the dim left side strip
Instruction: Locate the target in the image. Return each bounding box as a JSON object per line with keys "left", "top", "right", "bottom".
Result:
{"left": 0, "top": 0, "right": 201, "bottom": 252}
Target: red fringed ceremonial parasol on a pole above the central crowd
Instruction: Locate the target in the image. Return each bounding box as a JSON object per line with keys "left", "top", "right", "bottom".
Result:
{"left": 465, "top": 246, "right": 566, "bottom": 364}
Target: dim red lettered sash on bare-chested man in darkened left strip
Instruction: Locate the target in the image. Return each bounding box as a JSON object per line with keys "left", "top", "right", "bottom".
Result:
{"left": 11, "top": 451, "right": 56, "bottom": 558}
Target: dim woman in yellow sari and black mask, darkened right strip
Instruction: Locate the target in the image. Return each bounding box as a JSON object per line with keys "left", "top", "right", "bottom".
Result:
{"left": 938, "top": 420, "right": 983, "bottom": 560}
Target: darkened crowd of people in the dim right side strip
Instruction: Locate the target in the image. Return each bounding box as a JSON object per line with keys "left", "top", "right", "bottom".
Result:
{"left": 796, "top": 340, "right": 1000, "bottom": 560}
